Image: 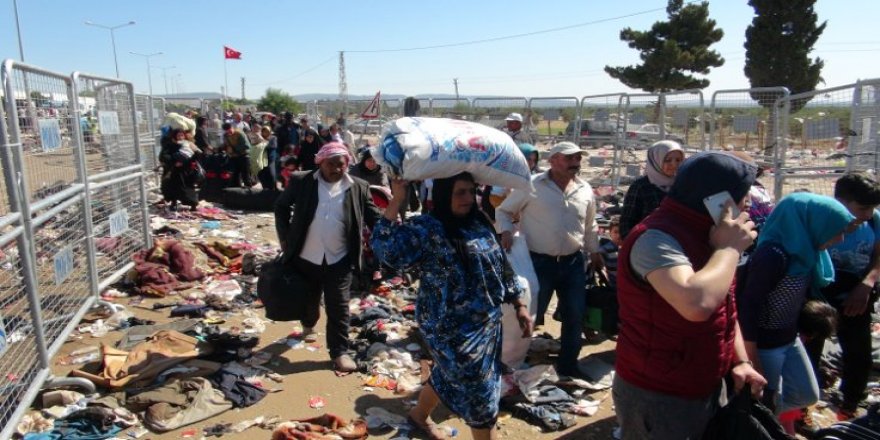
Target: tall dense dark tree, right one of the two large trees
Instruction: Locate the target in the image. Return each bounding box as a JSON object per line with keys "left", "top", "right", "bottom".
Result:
{"left": 743, "top": 0, "right": 826, "bottom": 113}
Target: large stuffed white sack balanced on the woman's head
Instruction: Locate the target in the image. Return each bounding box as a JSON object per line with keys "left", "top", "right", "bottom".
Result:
{"left": 373, "top": 118, "right": 531, "bottom": 190}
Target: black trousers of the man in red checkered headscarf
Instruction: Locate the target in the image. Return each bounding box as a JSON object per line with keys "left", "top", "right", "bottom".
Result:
{"left": 296, "top": 256, "right": 352, "bottom": 359}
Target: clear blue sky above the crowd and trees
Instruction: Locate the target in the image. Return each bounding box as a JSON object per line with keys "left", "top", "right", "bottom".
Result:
{"left": 0, "top": 0, "right": 880, "bottom": 98}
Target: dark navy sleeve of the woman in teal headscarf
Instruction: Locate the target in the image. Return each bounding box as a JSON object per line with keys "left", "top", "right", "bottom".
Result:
{"left": 736, "top": 245, "right": 788, "bottom": 342}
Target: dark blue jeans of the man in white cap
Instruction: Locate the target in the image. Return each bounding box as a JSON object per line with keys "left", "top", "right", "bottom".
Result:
{"left": 531, "top": 252, "right": 587, "bottom": 375}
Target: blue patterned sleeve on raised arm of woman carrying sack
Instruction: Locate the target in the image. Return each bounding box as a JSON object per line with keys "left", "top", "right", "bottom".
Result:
{"left": 370, "top": 216, "right": 430, "bottom": 270}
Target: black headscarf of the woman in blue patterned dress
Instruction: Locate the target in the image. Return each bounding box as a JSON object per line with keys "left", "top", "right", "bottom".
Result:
{"left": 431, "top": 173, "right": 494, "bottom": 268}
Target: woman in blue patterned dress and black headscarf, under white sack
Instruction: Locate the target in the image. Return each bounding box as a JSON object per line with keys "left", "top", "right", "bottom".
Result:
{"left": 372, "top": 173, "right": 532, "bottom": 439}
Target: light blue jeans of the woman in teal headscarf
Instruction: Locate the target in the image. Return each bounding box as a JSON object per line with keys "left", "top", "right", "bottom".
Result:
{"left": 758, "top": 338, "right": 819, "bottom": 414}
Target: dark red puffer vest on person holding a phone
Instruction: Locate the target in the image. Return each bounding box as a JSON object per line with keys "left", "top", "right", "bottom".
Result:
{"left": 615, "top": 197, "right": 736, "bottom": 399}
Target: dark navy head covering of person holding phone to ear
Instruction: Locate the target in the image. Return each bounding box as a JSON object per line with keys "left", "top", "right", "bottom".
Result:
{"left": 668, "top": 151, "right": 758, "bottom": 215}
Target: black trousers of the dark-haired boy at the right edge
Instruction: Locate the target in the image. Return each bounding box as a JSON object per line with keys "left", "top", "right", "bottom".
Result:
{"left": 805, "top": 295, "right": 875, "bottom": 410}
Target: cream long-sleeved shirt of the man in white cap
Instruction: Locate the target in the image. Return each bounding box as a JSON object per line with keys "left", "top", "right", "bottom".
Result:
{"left": 495, "top": 171, "right": 599, "bottom": 257}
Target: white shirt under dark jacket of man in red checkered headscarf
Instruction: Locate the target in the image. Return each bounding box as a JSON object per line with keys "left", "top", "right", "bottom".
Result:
{"left": 299, "top": 171, "right": 354, "bottom": 266}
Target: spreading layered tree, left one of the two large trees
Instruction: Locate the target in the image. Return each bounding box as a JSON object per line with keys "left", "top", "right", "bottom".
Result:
{"left": 605, "top": 0, "right": 724, "bottom": 93}
